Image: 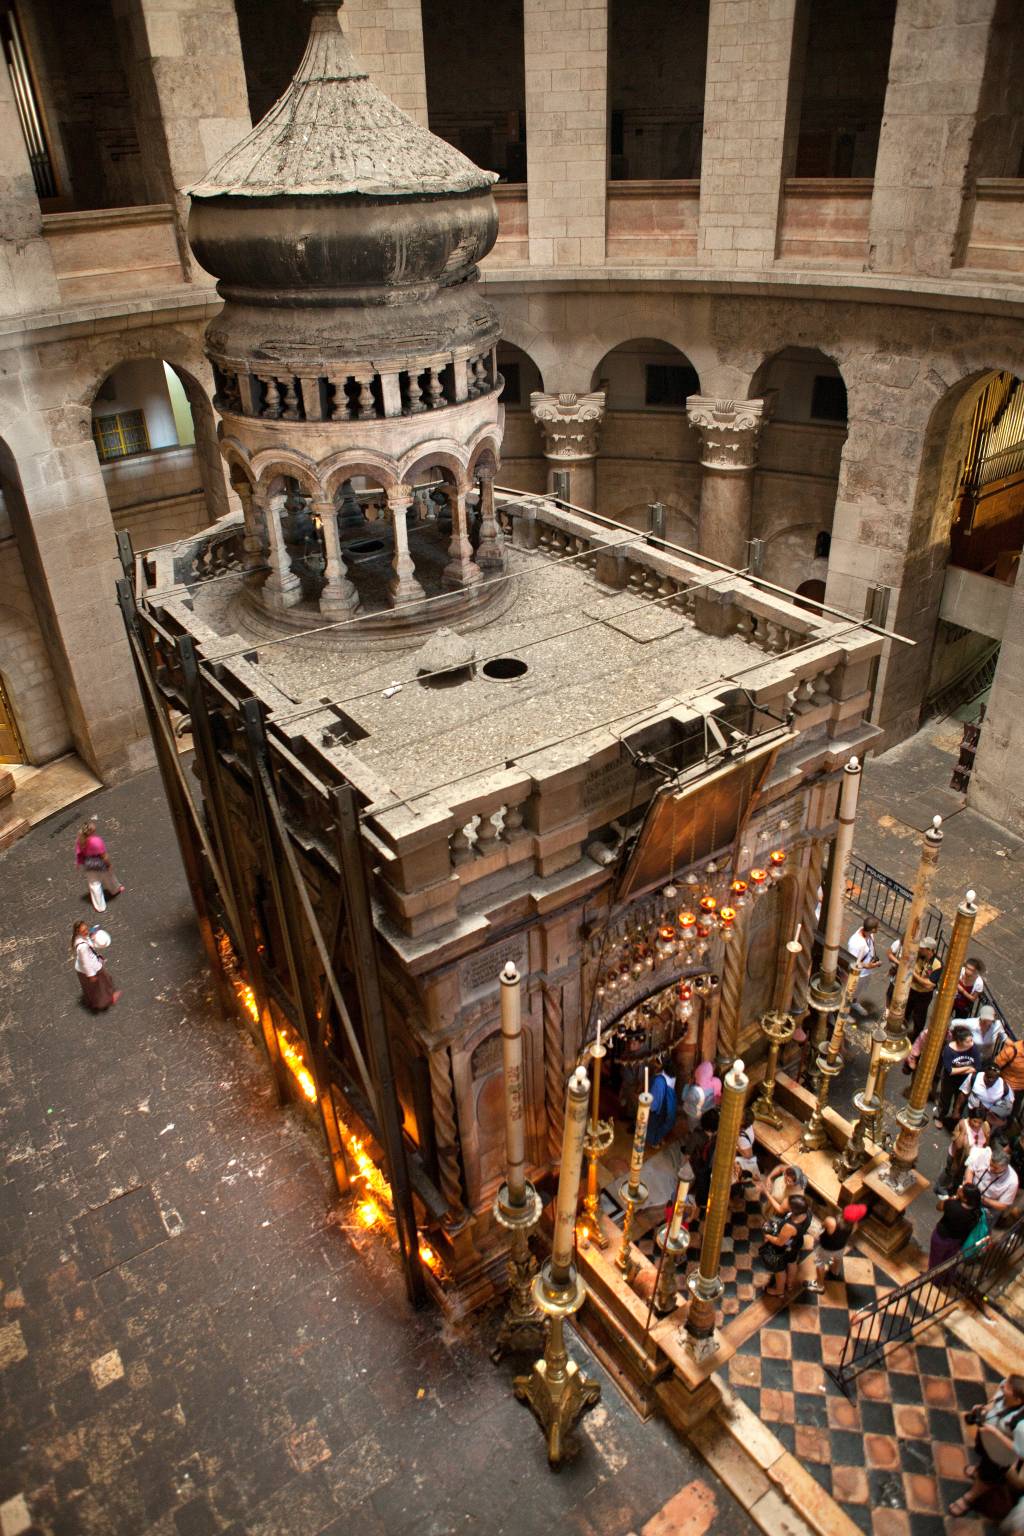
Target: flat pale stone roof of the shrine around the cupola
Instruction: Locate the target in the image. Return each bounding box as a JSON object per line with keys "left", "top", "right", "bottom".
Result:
{"left": 193, "top": 538, "right": 765, "bottom": 796}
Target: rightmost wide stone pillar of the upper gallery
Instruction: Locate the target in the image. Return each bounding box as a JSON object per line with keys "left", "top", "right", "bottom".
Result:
{"left": 867, "top": 0, "right": 999, "bottom": 276}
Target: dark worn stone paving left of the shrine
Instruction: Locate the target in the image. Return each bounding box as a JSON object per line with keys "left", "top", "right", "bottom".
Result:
{"left": 0, "top": 774, "right": 751, "bottom": 1536}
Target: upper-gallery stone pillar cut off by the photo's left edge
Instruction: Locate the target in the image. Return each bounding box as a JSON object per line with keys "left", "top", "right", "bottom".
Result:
{"left": 0, "top": 48, "right": 60, "bottom": 315}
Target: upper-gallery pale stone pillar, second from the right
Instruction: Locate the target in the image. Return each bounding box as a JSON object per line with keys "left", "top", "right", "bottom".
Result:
{"left": 697, "top": 0, "right": 806, "bottom": 269}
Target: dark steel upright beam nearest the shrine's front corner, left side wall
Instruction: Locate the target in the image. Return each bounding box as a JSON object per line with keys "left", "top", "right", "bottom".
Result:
{"left": 332, "top": 783, "right": 427, "bottom": 1307}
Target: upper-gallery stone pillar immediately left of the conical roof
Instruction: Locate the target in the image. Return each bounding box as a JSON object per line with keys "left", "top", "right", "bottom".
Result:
{"left": 114, "top": 0, "right": 252, "bottom": 283}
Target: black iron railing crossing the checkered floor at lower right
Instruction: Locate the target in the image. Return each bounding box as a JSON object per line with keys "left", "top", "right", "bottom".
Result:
{"left": 824, "top": 1217, "right": 1024, "bottom": 1398}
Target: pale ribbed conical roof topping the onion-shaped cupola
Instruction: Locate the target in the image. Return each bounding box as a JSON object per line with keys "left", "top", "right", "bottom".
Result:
{"left": 189, "top": 0, "right": 497, "bottom": 198}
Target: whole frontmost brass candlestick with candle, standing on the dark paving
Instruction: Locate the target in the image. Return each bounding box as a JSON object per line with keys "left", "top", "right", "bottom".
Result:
{"left": 513, "top": 1068, "right": 600, "bottom": 1467}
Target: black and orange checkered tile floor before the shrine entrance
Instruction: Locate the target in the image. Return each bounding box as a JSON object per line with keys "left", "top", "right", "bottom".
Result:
{"left": 728, "top": 1253, "right": 998, "bottom": 1536}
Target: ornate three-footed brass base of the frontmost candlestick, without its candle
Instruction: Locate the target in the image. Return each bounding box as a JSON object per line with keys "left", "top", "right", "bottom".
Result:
{"left": 513, "top": 1260, "right": 600, "bottom": 1471}
